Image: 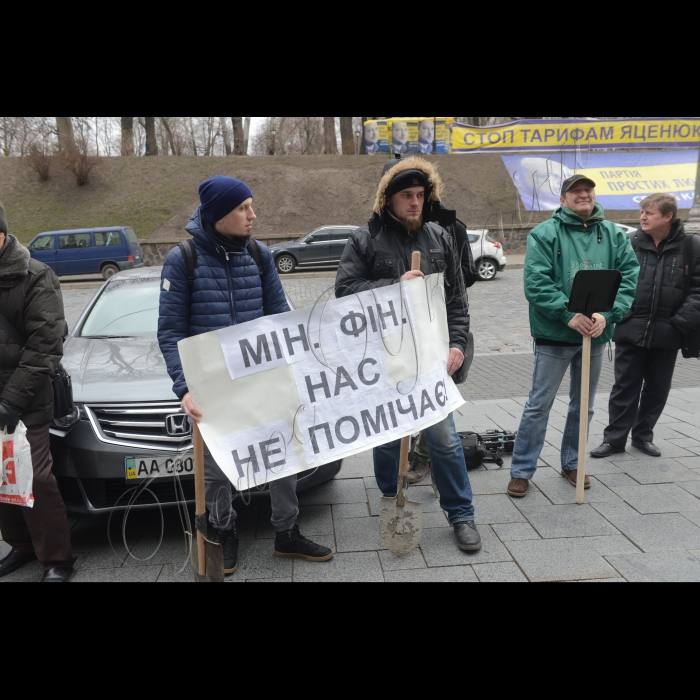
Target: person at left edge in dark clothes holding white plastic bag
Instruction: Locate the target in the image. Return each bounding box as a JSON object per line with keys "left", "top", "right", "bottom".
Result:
{"left": 0, "top": 204, "right": 76, "bottom": 583}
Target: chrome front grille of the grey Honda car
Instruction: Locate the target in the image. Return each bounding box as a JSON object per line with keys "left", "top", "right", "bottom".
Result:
{"left": 85, "top": 402, "right": 192, "bottom": 453}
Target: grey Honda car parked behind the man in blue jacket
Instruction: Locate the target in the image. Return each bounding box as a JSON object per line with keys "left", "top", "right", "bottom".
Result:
{"left": 51, "top": 267, "right": 342, "bottom": 515}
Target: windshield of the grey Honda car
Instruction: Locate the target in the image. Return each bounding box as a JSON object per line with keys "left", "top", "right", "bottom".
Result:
{"left": 80, "top": 278, "right": 160, "bottom": 338}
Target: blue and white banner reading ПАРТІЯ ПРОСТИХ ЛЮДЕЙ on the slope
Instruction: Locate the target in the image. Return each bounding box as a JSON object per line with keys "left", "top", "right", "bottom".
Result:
{"left": 503, "top": 150, "right": 699, "bottom": 211}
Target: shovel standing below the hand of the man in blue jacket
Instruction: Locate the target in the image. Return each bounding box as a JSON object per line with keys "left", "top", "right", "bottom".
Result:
{"left": 190, "top": 423, "right": 224, "bottom": 583}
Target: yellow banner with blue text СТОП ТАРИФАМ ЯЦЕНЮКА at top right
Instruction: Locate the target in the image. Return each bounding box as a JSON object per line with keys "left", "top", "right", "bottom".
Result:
{"left": 452, "top": 118, "right": 700, "bottom": 153}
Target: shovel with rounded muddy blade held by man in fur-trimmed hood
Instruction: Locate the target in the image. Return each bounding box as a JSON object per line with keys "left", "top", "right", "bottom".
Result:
{"left": 379, "top": 253, "right": 423, "bottom": 557}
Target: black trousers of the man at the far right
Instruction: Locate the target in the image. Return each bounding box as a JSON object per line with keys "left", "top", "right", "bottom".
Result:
{"left": 605, "top": 344, "right": 678, "bottom": 449}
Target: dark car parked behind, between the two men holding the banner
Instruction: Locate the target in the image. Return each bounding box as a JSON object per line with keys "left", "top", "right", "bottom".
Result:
{"left": 270, "top": 226, "right": 359, "bottom": 275}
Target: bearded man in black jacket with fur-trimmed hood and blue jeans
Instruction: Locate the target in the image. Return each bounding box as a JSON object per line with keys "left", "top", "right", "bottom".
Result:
{"left": 336, "top": 157, "right": 482, "bottom": 552}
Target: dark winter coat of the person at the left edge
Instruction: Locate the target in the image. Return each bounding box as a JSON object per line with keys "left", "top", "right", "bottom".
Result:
{"left": 0, "top": 236, "right": 65, "bottom": 427}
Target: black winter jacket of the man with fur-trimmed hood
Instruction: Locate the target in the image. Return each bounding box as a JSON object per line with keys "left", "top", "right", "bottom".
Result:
{"left": 336, "top": 214, "right": 469, "bottom": 353}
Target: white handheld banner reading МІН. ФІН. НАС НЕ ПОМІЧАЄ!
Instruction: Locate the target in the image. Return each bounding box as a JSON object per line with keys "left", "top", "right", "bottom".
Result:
{"left": 178, "top": 275, "right": 464, "bottom": 491}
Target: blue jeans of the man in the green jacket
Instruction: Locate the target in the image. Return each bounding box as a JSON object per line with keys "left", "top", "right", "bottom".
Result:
{"left": 511, "top": 345, "right": 605, "bottom": 481}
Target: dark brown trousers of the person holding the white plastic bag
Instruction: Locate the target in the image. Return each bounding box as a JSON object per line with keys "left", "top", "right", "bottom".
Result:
{"left": 0, "top": 425, "right": 75, "bottom": 570}
